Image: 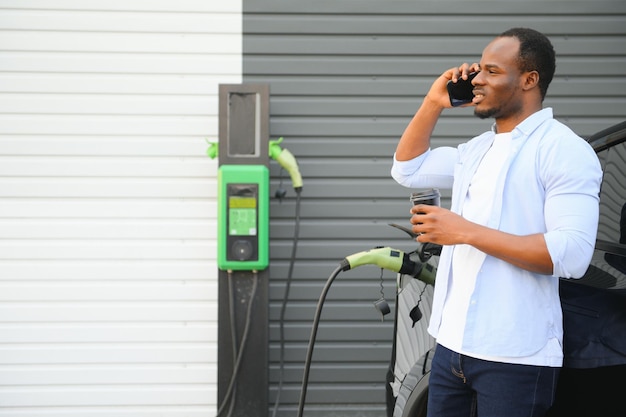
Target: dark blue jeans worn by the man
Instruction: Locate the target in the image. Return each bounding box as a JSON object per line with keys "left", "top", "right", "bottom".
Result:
{"left": 428, "top": 345, "right": 559, "bottom": 417}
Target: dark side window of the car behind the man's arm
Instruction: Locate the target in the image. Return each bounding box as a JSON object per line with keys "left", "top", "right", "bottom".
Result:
{"left": 580, "top": 134, "right": 626, "bottom": 289}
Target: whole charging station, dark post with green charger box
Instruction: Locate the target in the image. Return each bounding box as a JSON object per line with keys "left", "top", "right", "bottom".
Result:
{"left": 209, "top": 84, "right": 269, "bottom": 417}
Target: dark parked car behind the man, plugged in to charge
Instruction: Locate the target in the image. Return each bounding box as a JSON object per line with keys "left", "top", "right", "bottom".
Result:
{"left": 387, "top": 122, "right": 626, "bottom": 417}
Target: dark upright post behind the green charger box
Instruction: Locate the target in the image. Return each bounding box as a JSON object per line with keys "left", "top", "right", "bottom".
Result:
{"left": 217, "top": 84, "right": 269, "bottom": 417}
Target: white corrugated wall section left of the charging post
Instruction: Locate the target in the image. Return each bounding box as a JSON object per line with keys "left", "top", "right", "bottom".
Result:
{"left": 0, "top": 0, "right": 242, "bottom": 417}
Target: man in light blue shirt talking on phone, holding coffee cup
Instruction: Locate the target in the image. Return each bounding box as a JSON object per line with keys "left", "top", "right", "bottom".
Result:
{"left": 392, "top": 28, "right": 602, "bottom": 417}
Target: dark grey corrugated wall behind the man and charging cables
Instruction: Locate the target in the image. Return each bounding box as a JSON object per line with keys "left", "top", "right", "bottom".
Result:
{"left": 243, "top": 0, "right": 626, "bottom": 416}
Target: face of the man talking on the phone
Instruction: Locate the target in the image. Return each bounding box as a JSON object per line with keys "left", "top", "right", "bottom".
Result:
{"left": 473, "top": 37, "right": 523, "bottom": 119}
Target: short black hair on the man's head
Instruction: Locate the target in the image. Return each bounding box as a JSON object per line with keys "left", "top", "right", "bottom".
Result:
{"left": 499, "top": 28, "right": 556, "bottom": 100}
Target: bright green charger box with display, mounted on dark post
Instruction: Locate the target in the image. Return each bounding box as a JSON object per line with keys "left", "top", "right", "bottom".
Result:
{"left": 217, "top": 165, "right": 269, "bottom": 271}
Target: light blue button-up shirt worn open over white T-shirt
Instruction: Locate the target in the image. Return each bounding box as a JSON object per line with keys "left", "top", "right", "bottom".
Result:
{"left": 391, "top": 108, "right": 602, "bottom": 357}
